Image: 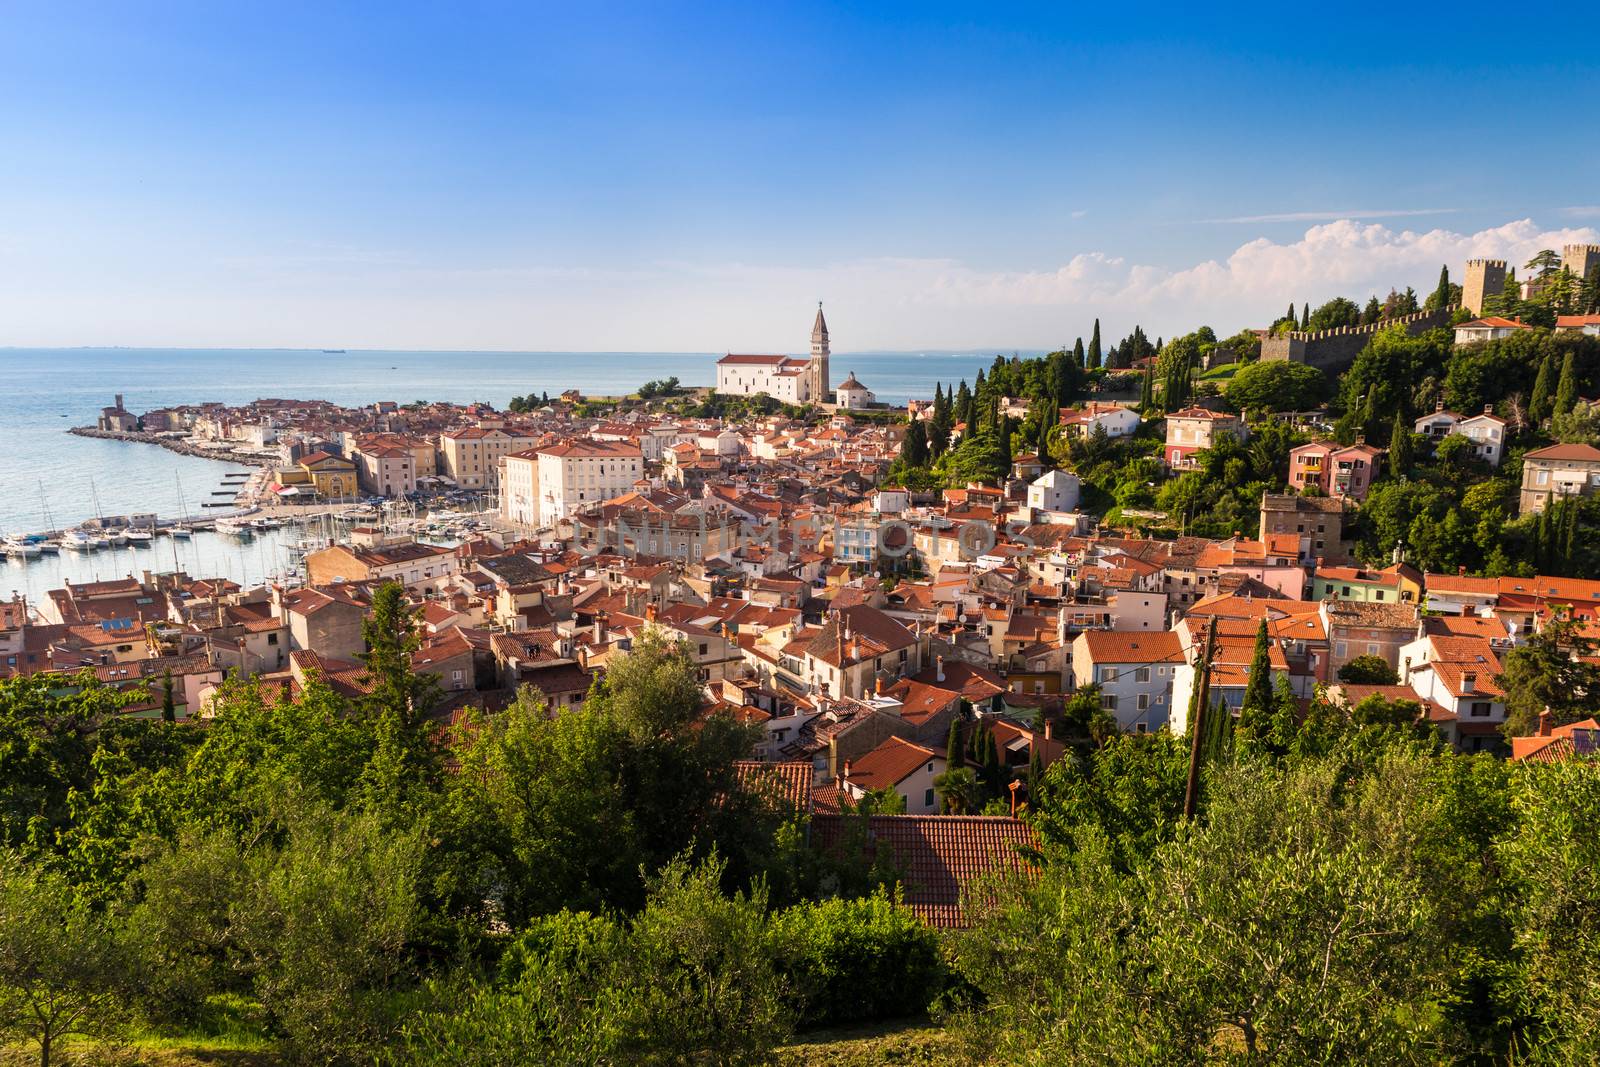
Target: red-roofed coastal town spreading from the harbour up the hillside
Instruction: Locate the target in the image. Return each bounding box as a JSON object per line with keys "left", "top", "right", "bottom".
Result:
{"left": 9, "top": 246, "right": 1600, "bottom": 825}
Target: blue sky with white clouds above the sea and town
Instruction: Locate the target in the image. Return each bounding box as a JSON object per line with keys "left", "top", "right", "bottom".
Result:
{"left": 0, "top": 2, "right": 1600, "bottom": 350}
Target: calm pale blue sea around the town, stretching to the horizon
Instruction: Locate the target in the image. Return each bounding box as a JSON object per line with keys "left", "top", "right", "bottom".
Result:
{"left": 0, "top": 349, "right": 1030, "bottom": 537}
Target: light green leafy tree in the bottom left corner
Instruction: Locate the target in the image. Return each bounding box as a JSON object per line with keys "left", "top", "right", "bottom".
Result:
{"left": 0, "top": 849, "right": 126, "bottom": 1067}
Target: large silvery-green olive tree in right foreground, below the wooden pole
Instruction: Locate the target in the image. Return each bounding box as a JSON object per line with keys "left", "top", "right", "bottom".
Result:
{"left": 954, "top": 757, "right": 1464, "bottom": 1064}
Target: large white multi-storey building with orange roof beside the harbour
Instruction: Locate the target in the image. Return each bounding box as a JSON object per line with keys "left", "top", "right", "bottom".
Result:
{"left": 501, "top": 440, "right": 645, "bottom": 526}
